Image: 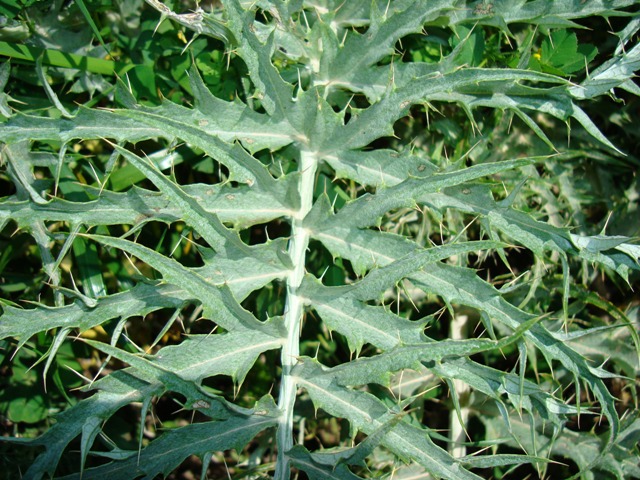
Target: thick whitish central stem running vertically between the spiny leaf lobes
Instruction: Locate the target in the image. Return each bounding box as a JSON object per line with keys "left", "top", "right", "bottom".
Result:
{"left": 274, "top": 150, "right": 318, "bottom": 480}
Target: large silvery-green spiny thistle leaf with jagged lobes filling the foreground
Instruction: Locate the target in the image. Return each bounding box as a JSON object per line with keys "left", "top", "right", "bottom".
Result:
{"left": 0, "top": 0, "right": 639, "bottom": 480}
